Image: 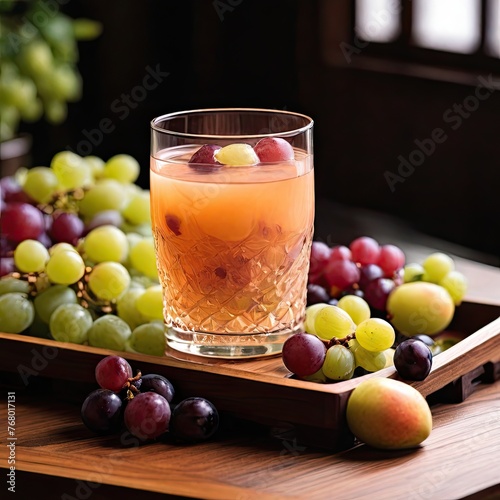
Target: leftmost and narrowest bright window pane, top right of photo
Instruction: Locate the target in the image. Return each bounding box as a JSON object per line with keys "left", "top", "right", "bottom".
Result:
{"left": 355, "top": 0, "right": 401, "bottom": 42}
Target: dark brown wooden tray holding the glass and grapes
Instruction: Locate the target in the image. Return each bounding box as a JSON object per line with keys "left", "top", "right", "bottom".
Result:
{"left": 0, "top": 302, "right": 500, "bottom": 450}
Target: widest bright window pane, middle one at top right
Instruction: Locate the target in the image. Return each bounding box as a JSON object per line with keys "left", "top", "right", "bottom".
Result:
{"left": 412, "top": 0, "right": 482, "bottom": 54}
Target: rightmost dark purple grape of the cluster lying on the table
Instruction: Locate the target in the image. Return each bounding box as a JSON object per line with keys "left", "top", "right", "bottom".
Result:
{"left": 169, "top": 397, "right": 219, "bottom": 442}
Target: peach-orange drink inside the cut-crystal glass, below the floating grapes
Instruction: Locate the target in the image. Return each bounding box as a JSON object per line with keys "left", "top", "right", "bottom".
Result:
{"left": 151, "top": 146, "right": 314, "bottom": 343}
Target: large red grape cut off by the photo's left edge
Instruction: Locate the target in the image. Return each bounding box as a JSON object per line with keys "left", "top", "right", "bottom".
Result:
{"left": 0, "top": 202, "right": 45, "bottom": 243}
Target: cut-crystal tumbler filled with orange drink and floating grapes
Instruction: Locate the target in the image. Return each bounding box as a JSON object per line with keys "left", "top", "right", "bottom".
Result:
{"left": 150, "top": 108, "right": 314, "bottom": 359}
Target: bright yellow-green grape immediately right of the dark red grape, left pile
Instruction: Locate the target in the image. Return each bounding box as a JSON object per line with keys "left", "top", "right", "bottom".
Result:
{"left": 83, "top": 225, "right": 128, "bottom": 262}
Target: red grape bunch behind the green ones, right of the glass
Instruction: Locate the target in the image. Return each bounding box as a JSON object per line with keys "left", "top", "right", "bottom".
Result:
{"left": 307, "top": 236, "right": 405, "bottom": 312}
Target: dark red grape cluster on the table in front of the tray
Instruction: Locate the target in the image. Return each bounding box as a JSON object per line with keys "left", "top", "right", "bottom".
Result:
{"left": 81, "top": 355, "right": 219, "bottom": 443}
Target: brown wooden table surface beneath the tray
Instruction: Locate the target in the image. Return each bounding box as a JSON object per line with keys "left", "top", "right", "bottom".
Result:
{"left": 0, "top": 240, "right": 500, "bottom": 500}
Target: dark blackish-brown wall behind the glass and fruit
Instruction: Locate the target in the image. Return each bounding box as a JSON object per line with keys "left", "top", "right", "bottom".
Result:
{"left": 18, "top": 0, "right": 500, "bottom": 257}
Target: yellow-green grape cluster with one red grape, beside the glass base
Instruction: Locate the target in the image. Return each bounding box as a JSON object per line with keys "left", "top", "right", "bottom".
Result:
{"left": 282, "top": 295, "right": 396, "bottom": 382}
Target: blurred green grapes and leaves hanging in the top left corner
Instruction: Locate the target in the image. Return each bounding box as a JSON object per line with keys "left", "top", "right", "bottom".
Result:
{"left": 0, "top": 0, "right": 101, "bottom": 141}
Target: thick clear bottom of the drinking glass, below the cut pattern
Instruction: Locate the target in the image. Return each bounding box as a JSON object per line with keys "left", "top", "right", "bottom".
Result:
{"left": 166, "top": 327, "right": 299, "bottom": 359}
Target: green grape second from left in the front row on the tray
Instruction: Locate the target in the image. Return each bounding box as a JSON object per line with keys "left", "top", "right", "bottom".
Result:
{"left": 49, "top": 304, "right": 93, "bottom": 344}
